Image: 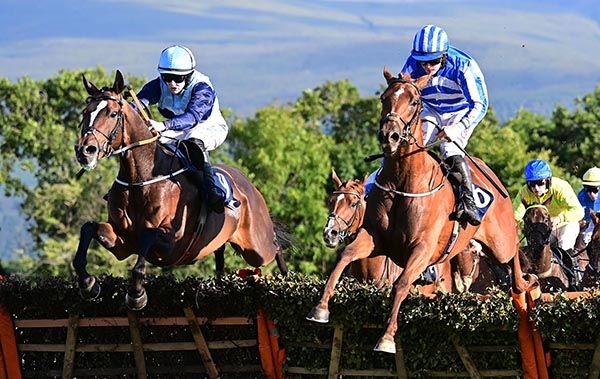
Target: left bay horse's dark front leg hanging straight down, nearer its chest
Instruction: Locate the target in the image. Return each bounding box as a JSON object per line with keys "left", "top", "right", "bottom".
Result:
{"left": 125, "top": 228, "right": 159, "bottom": 311}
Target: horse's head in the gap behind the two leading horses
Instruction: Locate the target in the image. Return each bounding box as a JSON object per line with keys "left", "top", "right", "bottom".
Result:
{"left": 323, "top": 170, "right": 367, "bottom": 247}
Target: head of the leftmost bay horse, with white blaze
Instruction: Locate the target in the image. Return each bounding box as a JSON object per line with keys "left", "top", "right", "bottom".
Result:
{"left": 75, "top": 70, "right": 126, "bottom": 170}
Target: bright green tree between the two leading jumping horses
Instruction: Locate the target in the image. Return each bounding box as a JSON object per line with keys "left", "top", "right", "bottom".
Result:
{"left": 229, "top": 106, "right": 332, "bottom": 273}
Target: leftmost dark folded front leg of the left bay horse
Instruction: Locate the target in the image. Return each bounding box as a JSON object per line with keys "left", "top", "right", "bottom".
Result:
{"left": 73, "top": 221, "right": 100, "bottom": 299}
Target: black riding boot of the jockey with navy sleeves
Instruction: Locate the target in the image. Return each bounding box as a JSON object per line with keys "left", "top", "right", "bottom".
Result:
{"left": 188, "top": 138, "right": 225, "bottom": 213}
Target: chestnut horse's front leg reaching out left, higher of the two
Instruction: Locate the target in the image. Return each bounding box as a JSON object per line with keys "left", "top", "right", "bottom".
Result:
{"left": 306, "top": 228, "right": 375, "bottom": 323}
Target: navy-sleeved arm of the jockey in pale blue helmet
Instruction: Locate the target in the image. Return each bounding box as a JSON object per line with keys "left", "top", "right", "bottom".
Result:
{"left": 165, "top": 83, "right": 216, "bottom": 130}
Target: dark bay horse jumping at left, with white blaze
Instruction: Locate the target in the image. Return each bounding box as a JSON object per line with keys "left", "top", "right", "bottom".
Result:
{"left": 73, "top": 70, "right": 289, "bottom": 310}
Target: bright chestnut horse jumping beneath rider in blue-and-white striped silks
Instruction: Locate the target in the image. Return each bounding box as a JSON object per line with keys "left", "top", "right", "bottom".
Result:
{"left": 307, "top": 68, "right": 530, "bottom": 353}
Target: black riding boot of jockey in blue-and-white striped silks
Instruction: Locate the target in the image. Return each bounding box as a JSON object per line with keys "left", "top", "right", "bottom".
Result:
{"left": 446, "top": 155, "right": 481, "bottom": 226}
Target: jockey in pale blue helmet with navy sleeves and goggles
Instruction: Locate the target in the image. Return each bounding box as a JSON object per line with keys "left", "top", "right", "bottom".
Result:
{"left": 132, "top": 45, "right": 229, "bottom": 212}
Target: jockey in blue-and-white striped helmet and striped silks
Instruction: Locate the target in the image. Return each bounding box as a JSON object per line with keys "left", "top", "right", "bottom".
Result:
{"left": 402, "top": 25, "right": 488, "bottom": 225}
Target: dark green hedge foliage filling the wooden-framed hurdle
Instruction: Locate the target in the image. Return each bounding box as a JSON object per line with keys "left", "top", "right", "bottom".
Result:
{"left": 0, "top": 274, "right": 600, "bottom": 377}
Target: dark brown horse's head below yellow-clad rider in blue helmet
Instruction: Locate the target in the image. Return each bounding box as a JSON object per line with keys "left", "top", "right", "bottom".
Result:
{"left": 523, "top": 204, "right": 552, "bottom": 273}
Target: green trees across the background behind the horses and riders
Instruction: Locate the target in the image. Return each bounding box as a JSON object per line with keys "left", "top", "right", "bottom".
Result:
{"left": 0, "top": 67, "right": 600, "bottom": 277}
